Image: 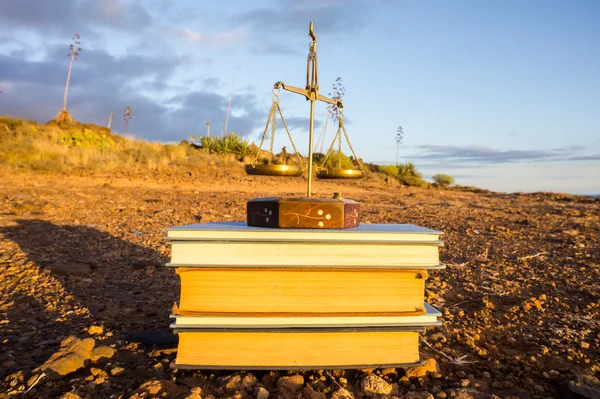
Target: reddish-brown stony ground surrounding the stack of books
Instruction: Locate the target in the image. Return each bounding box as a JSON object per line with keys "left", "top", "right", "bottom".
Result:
{"left": 0, "top": 172, "right": 600, "bottom": 399}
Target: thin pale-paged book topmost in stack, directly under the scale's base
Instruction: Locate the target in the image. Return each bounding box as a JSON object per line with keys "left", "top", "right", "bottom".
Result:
{"left": 165, "top": 222, "right": 443, "bottom": 244}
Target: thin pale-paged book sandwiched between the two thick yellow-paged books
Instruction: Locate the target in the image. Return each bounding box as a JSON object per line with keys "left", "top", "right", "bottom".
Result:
{"left": 171, "top": 303, "right": 442, "bottom": 331}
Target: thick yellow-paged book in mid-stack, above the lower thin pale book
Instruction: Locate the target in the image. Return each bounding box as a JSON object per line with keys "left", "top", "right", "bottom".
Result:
{"left": 175, "top": 267, "right": 427, "bottom": 317}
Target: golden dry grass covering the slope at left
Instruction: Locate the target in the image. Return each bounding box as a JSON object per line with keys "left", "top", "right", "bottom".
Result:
{"left": 0, "top": 118, "right": 239, "bottom": 177}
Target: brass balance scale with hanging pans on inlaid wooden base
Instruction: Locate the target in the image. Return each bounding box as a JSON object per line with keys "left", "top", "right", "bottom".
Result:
{"left": 246, "top": 22, "right": 365, "bottom": 229}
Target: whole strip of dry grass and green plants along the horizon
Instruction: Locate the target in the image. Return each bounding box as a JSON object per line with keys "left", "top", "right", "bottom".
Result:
{"left": 0, "top": 117, "right": 454, "bottom": 193}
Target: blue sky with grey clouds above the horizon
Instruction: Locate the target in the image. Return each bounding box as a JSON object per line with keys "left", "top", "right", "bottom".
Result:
{"left": 0, "top": 0, "right": 600, "bottom": 194}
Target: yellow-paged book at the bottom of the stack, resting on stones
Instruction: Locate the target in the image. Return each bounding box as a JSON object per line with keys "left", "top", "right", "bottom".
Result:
{"left": 175, "top": 328, "right": 422, "bottom": 370}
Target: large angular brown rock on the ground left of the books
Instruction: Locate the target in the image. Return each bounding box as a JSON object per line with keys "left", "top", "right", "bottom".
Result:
{"left": 34, "top": 336, "right": 95, "bottom": 380}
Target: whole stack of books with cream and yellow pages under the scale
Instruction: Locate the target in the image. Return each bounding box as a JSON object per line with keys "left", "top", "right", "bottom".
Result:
{"left": 166, "top": 223, "right": 444, "bottom": 369}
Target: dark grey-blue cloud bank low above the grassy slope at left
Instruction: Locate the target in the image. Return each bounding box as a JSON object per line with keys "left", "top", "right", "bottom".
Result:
{"left": 0, "top": 42, "right": 266, "bottom": 141}
